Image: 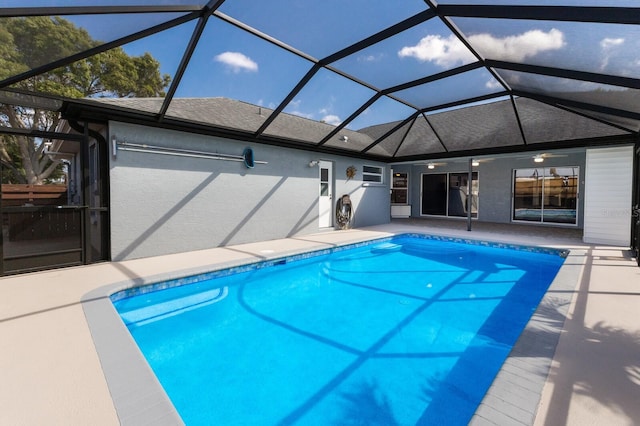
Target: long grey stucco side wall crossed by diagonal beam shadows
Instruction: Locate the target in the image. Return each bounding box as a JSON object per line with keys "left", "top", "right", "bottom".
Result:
{"left": 109, "top": 122, "right": 390, "bottom": 260}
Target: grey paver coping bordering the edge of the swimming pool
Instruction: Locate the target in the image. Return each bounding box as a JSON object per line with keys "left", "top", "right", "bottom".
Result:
{"left": 82, "top": 232, "right": 583, "bottom": 425}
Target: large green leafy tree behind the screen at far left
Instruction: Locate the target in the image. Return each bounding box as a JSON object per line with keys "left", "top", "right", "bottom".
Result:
{"left": 0, "top": 16, "right": 171, "bottom": 184}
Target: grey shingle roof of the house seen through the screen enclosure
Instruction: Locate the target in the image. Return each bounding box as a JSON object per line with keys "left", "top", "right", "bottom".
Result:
{"left": 82, "top": 94, "right": 629, "bottom": 158}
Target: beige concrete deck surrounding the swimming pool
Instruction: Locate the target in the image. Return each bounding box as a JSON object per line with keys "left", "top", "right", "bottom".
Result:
{"left": 0, "top": 220, "right": 640, "bottom": 425}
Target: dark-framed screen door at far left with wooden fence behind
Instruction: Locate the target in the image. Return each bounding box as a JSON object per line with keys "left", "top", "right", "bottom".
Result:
{"left": 1, "top": 137, "right": 85, "bottom": 274}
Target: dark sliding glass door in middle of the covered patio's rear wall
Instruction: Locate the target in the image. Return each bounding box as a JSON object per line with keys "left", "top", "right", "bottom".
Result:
{"left": 421, "top": 172, "right": 479, "bottom": 217}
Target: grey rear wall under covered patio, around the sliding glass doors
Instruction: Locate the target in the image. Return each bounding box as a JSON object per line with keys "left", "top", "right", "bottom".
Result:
{"left": 392, "top": 149, "right": 586, "bottom": 228}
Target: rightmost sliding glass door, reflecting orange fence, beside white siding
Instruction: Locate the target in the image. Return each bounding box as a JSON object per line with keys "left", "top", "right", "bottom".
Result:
{"left": 512, "top": 166, "right": 580, "bottom": 225}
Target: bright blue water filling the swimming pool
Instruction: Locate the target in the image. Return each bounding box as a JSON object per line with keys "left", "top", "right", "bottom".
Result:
{"left": 112, "top": 235, "right": 564, "bottom": 426}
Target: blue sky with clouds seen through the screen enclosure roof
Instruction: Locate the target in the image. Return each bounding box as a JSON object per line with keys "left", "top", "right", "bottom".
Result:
{"left": 56, "top": 0, "right": 640, "bottom": 129}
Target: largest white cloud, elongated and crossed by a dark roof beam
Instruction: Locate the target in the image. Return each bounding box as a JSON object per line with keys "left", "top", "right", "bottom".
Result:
{"left": 398, "top": 28, "right": 565, "bottom": 67}
